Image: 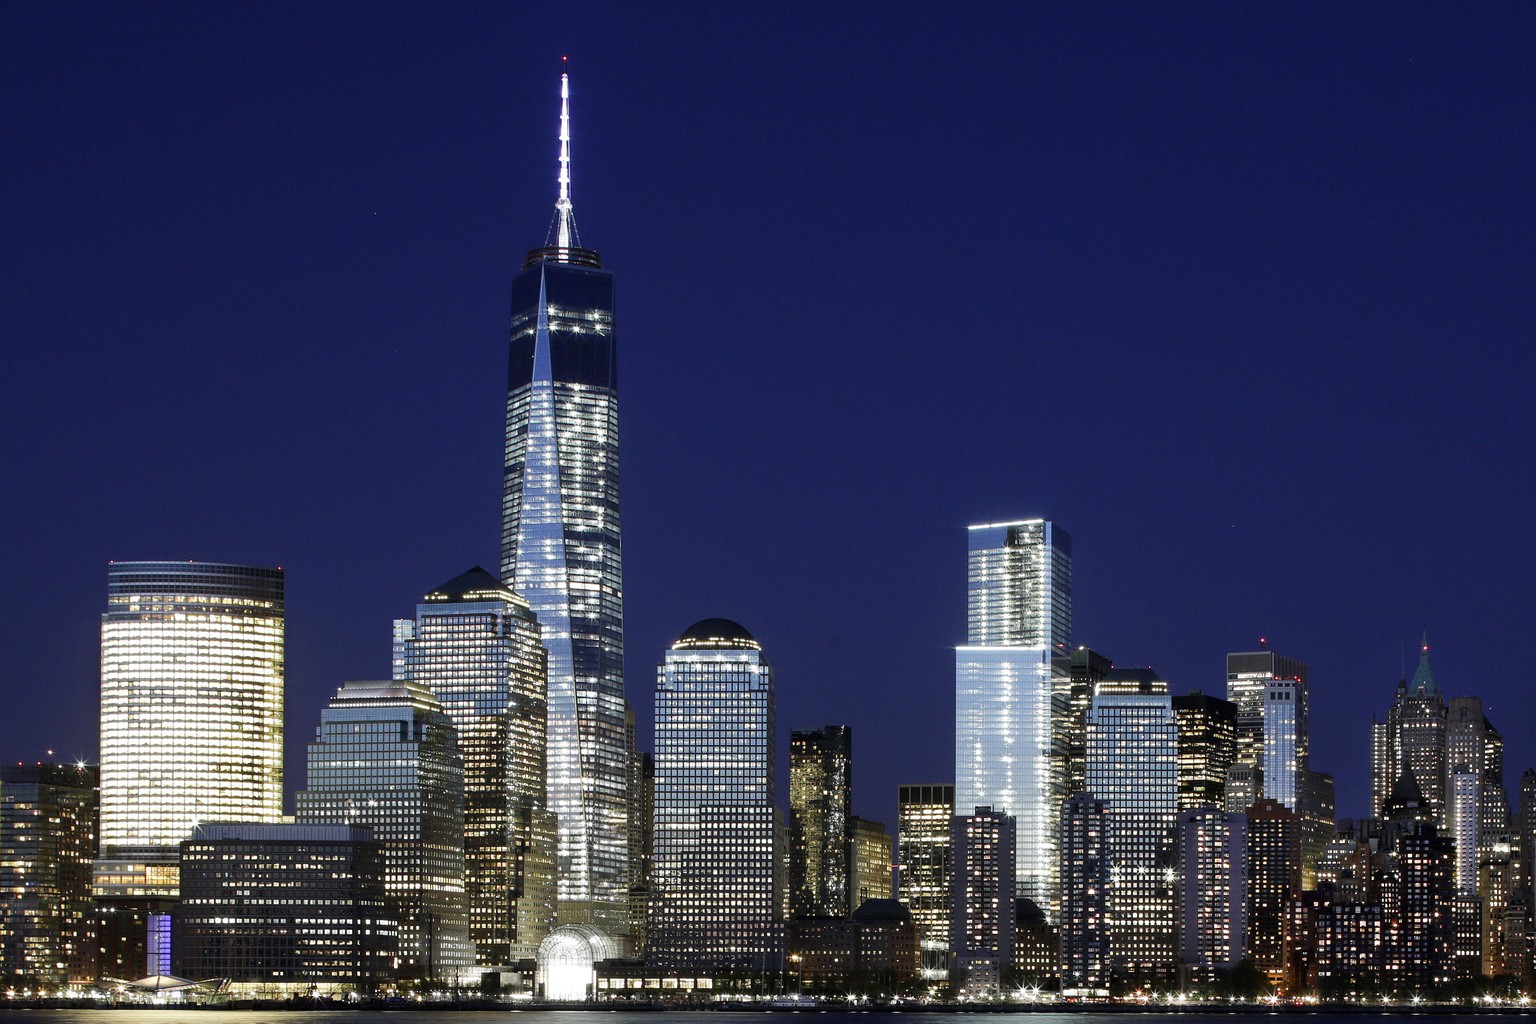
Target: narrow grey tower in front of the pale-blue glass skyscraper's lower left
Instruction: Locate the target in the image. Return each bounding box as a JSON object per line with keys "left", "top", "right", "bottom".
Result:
{"left": 949, "top": 808, "right": 1015, "bottom": 998}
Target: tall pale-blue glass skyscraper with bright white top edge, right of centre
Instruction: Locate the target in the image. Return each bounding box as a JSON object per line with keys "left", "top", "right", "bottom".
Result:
{"left": 955, "top": 519, "right": 1072, "bottom": 918}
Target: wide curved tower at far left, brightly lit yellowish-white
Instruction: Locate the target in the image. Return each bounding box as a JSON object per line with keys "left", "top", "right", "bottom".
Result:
{"left": 95, "top": 562, "right": 283, "bottom": 914}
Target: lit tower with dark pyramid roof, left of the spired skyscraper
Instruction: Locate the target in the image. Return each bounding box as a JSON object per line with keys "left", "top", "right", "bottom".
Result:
{"left": 395, "top": 567, "right": 554, "bottom": 964}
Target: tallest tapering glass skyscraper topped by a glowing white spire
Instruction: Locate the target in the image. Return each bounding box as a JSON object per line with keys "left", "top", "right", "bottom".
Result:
{"left": 501, "top": 75, "right": 630, "bottom": 930}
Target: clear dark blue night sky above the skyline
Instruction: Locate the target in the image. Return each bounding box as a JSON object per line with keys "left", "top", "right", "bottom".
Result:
{"left": 0, "top": 3, "right": 1536, "bottom": 826}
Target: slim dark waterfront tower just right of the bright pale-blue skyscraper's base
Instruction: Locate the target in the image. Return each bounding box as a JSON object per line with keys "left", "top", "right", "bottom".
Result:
{"left": 1060, "top": 794, "right": 1112, "bottom": 996}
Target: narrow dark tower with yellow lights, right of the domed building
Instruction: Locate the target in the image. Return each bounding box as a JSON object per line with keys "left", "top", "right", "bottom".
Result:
{"left": 790, "top": 725, "right": 859, "bottom": 918}
